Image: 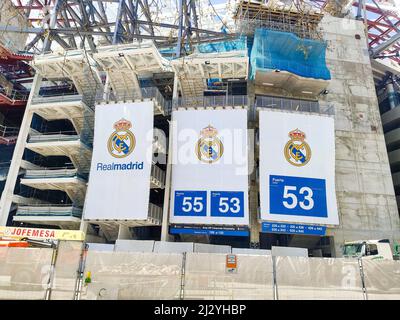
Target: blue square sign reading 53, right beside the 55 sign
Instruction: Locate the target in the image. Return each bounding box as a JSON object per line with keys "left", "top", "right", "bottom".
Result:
{"left": 211, "top": 191, "right": 244, "bottom": 218}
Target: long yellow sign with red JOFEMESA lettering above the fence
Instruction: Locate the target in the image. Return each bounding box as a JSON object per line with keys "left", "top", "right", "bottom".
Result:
{"left": 0, "top": 227, "right": 85, "bottom": 241}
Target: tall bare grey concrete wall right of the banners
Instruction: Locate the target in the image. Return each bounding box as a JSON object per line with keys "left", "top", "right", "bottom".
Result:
{"left": 320, "top": 16, "right": 400, "bottom": 256}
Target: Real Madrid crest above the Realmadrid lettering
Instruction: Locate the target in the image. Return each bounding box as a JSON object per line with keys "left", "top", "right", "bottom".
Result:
{"left": 107, "top": 119, "right": 136, "bottom": 158}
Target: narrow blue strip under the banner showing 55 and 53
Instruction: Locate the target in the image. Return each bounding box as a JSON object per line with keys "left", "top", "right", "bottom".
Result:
{"left": 169, "top": 225, "right": 250, "bottom": 237}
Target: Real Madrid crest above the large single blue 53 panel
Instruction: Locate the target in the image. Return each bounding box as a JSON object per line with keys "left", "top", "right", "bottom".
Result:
{"left": 284, "top": 129, "right": 311, "bottom": 167}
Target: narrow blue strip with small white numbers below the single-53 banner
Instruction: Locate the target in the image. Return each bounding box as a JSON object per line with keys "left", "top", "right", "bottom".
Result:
{"left": 261, "top": 222, "right": 326, "bottom": 236}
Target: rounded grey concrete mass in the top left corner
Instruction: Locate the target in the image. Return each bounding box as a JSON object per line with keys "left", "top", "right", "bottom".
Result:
{"left": 0, "top": 0, "right": 28, "bottom": 51}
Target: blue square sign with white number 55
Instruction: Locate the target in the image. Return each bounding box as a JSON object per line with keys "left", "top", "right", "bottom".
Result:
{"left": 174, "top": 191, "right": 207, "bottom": 217}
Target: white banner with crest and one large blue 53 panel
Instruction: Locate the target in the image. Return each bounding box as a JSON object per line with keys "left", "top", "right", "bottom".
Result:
{"left": 259, "top": 110, "right": 339, "bottom": 225}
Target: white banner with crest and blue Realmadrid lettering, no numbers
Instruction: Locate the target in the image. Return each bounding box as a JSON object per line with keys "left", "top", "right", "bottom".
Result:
{"left": 84, "top": 102, "right": 153, "bottom": 220}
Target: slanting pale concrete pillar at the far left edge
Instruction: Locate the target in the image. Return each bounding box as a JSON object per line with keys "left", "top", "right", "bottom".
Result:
{"left": 0, "top": 73, "right": 42, "bottom": 226}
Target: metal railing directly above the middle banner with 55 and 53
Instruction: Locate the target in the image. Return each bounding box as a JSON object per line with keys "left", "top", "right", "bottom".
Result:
{"left": 173, "top": 95, "right": 249, "bottom": 108}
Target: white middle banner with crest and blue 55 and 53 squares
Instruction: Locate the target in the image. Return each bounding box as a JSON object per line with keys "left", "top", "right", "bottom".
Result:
{"left": 170, "top": 110, "right": 249, "bottom": 226}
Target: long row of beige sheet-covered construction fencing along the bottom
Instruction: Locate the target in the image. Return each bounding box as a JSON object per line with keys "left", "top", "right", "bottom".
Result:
{"left": 0, "top": 245, "right": 400, "bottom": 300}
